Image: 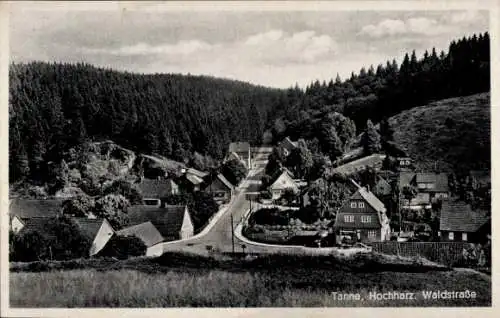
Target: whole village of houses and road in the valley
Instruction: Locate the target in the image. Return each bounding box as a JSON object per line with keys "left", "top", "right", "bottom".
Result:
{"left": 10, "top": 128, "right": 491, "bottom": 267}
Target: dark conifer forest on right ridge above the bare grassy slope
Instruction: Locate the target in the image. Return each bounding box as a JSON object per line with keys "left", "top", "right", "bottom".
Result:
{"left": 273, "top": 32, "right": 490, "bottom": 140}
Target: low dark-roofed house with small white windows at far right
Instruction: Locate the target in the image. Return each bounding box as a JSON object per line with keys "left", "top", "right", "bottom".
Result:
{"left": 438, "top": 201, "right": 491, "bottom": 242}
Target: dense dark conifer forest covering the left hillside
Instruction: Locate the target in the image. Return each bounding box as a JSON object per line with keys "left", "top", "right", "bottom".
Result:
{"left": 9, "top": 62, "right": 292, "bottom": 180}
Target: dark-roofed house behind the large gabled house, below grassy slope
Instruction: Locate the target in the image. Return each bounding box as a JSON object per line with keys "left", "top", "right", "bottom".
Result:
{"left": 398, "top": 172, "right": 449, "bottom": 200}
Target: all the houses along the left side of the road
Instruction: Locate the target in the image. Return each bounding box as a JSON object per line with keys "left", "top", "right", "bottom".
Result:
{"left": 9, "top": 143, "right": 251, "bottom": 256}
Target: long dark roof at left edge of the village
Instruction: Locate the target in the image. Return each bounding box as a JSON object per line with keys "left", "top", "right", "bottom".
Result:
{"left": 9, "top": 198, "right": 65, "bottom": 218}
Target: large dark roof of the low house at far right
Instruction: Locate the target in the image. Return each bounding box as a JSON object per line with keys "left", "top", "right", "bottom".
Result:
{"left": 439, "top": 201, "right": 490, "bottom": 232}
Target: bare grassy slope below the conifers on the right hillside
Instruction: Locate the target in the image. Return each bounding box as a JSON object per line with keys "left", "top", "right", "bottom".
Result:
{"left": 389, "top": 93, "right": 490, "bottom": 172}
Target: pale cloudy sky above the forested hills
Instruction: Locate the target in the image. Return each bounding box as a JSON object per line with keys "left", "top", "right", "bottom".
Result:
{"left": 9, "top": 2, "right": 489, "bottom": 88}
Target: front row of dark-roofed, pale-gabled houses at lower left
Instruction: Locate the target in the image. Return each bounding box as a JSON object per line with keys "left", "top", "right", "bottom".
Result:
{"left": 9, "top": 199, "right": 194, "bottom": 256}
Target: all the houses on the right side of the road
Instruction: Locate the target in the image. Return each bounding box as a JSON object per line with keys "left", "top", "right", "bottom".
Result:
{"left": 269, "top": 138, "right": 491, "bottom": 246}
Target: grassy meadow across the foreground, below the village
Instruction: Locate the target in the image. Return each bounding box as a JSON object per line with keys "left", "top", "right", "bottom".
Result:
{"left": 10, "top": 252, "right": 491, "bottom": 307}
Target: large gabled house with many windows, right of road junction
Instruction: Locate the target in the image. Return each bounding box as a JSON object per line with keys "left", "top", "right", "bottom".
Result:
{"left": 334, "top": 181, "right": 391, "bottom": 242}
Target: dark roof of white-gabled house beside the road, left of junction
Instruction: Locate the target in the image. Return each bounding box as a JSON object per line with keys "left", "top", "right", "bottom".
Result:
{"left": 128, "top": 205, "right": 186, "bottom": 237}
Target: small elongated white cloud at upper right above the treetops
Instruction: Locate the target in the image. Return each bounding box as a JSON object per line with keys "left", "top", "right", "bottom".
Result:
{"left": 358, "top": 17, "right": 450, "bottom": 38}
